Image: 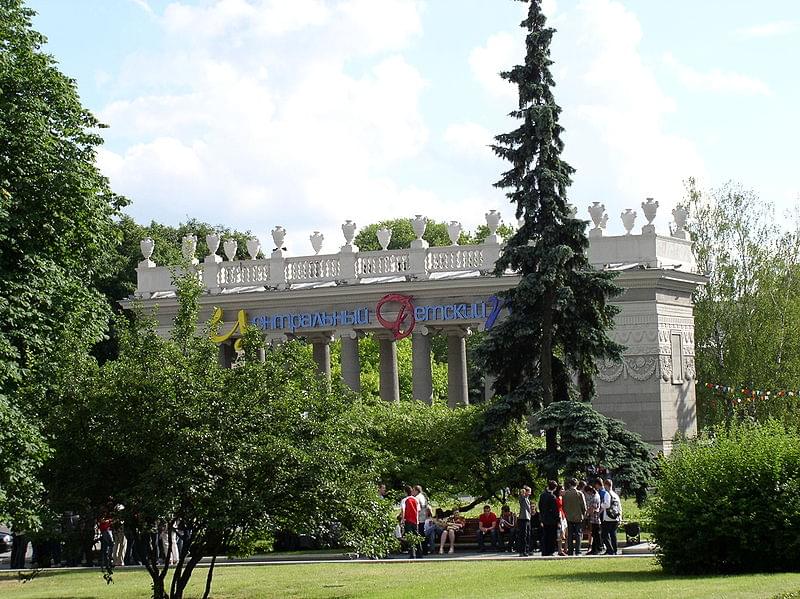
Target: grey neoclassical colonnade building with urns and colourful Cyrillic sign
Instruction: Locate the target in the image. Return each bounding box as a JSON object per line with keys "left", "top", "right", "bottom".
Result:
{"left": 128, "top": 199, "right": 705, "bottom": 451}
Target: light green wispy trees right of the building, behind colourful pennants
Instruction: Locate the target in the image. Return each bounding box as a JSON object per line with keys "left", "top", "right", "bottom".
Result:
{"left": 687, "top": 179, "right": 800, "bottom": 425}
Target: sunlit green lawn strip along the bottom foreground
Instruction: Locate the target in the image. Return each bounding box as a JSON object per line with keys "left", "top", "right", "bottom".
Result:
{"left": 0, "top": 558, "right": 800, "bottom": 599}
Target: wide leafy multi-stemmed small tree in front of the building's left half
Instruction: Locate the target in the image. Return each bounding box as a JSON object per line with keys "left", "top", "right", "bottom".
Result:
{"left": 43, "top": 275, "right": 395, "bottom": 597}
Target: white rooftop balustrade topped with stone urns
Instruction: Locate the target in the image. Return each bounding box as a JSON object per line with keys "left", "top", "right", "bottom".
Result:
{"left": 136, "top": 204, "right": 697, "bottom": 298}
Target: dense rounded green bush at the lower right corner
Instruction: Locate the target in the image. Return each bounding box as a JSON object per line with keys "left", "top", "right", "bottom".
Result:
{"left": 648, "top": 421, "right": 800, "bottom": 574}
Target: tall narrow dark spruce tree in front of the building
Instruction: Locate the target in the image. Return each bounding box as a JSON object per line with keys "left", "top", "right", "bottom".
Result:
{"left": 479, "top": 0, "right": 623, "bottom": 468}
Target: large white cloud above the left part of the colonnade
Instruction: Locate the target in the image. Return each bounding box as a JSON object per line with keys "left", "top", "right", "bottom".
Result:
{"left": 98, "top": 0, "right": 439, "bottom": 251}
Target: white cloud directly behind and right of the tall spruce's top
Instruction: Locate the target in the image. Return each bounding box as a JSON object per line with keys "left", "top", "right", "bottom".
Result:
{"left": 470, "top": 0, "right": 705, "bottom": 232}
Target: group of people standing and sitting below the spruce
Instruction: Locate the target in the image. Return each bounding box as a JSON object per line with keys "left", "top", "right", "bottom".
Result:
{"left": 394, "top": 477, "right": 622, "bottom": 558}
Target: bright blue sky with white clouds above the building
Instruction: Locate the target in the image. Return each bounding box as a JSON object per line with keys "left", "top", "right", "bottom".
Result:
{"left": 28, "top": 0, "right": 800, "bottom": 254}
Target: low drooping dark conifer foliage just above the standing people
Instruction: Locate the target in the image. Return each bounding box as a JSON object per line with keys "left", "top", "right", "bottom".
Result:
{"left": 534, "top": 401, "right": 656, "bottom": 504}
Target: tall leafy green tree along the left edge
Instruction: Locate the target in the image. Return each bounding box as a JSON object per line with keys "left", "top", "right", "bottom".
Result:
{"left": 0, "top": 0, "right": 125, "bottom": 526}
